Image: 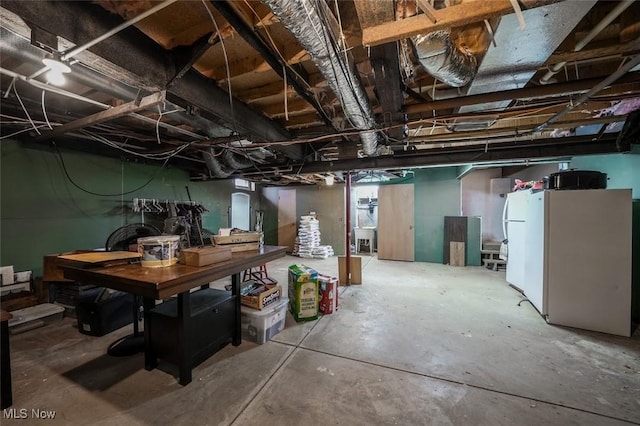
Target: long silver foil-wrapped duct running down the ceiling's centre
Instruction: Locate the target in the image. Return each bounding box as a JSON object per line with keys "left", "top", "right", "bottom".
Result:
{"left": 262, "top": 0, "right": 378, "bottom": 156}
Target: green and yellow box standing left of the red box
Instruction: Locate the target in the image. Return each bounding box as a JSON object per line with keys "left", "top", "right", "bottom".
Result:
{"left": 289, "top": 265, "right": 319, "bottom": 321}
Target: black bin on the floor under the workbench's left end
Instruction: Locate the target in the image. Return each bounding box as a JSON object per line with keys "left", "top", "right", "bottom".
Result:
{"left": 76, "top": 289, "right": 134, "bottom": 336}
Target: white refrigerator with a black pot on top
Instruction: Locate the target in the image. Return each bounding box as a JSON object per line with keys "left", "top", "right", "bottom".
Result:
{"left": 505, "top": 189, "right": 632, "bottom": 336}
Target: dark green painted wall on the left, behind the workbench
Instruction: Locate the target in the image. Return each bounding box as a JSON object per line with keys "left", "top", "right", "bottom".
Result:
{"left": 0, "top": 140, "right": 260, "bottom": 276}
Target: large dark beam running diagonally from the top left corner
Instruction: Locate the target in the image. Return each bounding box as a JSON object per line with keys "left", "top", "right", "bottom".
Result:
{"left": 2, "top": 0, "right": 303, "bottom": 159}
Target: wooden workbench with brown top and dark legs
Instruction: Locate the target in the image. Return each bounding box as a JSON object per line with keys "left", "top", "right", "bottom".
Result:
{"left": 60, "top": 246, "right": 287, "bottom": 385}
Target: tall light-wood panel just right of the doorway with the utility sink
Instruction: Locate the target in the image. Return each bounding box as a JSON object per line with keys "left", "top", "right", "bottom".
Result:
{"left": 378, "top": 184, "right": 415, "bottom": 262}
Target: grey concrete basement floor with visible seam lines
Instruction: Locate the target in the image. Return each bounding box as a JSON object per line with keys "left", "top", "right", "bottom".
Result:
{"left": 2, "top": 255, "right": 640, "bottom": 426}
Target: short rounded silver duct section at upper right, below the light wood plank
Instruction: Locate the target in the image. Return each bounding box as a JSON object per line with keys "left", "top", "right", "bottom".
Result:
{"left": 411, "top": 30, "right": 478, "bottom": 87}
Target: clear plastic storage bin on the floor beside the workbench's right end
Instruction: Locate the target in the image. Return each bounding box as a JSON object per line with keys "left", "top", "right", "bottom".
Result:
{"left": 240, "top": 298, "right": 289, "bottom": 344}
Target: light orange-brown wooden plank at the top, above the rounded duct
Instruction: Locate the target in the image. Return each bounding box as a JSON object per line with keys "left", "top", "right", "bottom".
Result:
{"left": 362, "top": 0, "right": 563, "bottom": 46}
